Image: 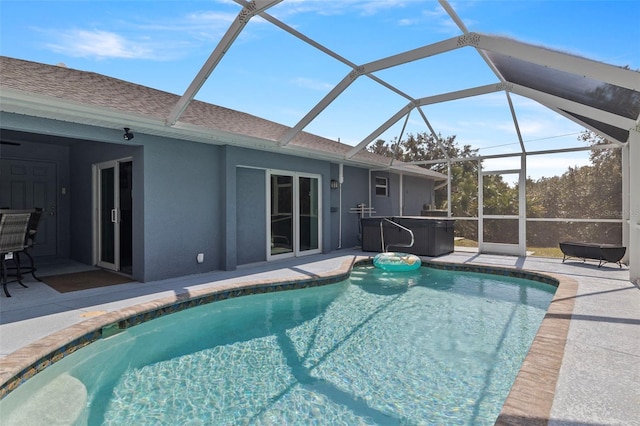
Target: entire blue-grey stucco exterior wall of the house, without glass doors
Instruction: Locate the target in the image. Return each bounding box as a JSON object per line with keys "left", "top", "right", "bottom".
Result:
{"left": 1, "top": 113, "right": 440, "bottom": 281}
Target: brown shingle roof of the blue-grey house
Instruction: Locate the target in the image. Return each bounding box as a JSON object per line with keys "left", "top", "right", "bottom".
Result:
{"left": 0, "top": 56, "right": 441, "bottom": 177}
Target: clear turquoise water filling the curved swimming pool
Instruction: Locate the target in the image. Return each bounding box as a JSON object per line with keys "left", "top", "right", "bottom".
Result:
{"left": 0, "top": 267, "right": 555, "bottom": 425}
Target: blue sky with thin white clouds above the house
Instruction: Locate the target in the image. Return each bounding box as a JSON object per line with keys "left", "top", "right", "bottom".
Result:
{"left": 0, "top": 0, "right": 640, "bottom": 179}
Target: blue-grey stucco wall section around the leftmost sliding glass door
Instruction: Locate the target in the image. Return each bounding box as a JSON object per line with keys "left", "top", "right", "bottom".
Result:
{"left": 59, "top": 130, "right": 221, "bottom": 281}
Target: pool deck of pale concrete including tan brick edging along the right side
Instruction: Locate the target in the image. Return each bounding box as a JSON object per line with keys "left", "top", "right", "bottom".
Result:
{"left": 0, "top": 250, "right": 640, "bottom": 426}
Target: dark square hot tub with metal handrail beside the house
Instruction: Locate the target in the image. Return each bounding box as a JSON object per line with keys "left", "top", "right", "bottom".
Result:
{"left": 360, "top": 216, "right": 455, "bottom": 257}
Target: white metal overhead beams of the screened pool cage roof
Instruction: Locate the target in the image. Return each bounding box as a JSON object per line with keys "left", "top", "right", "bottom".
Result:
{"left": 167, "top": 0, "right": 640, "bottom": 153}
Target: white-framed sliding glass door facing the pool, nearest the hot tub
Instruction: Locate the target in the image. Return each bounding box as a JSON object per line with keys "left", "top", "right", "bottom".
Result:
{"left": 267, "top": 171, "right": 321, "bottom": 258}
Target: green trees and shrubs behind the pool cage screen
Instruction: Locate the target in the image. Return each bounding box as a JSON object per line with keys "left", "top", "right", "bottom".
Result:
{"left": 368, "top": 131, "right": 622, "bottom": 247}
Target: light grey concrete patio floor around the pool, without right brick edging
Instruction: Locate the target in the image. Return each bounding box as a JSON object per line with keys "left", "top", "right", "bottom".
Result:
{"left": 0, "top": 250, "right": 640, "bottom": 426}
